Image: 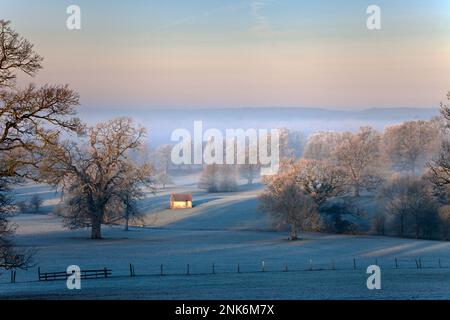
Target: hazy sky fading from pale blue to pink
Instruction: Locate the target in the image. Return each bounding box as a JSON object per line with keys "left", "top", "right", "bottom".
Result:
{"left": 0, "top": 0, "right": 450, "bottom": 109}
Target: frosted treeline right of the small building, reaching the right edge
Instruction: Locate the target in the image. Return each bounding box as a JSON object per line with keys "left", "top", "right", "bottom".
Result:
{"left": 260, "top": 110, "right": 450, "bottom": 240}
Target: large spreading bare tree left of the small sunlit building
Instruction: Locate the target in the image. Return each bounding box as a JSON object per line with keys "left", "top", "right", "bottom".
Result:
{"left": 41, "top": 118, "right": 152, "bottom": 239}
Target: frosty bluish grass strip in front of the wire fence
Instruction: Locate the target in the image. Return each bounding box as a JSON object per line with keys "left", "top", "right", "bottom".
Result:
{"left": 0, "top": 269, "right": 450, "bottom": 300}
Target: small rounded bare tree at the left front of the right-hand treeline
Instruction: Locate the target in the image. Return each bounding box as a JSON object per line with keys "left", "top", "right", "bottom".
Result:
{"left": 259, "top": 172, "right": 321, "bottom": 240}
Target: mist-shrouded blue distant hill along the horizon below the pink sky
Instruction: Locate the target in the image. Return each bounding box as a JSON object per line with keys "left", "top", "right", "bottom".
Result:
{"left": 80, "top": 107, "right": 439, "bottom": 144}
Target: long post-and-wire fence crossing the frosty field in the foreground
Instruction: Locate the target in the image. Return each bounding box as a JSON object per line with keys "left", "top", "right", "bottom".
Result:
{"left": 0, "top": 257, "right": 450, "bottom": 284}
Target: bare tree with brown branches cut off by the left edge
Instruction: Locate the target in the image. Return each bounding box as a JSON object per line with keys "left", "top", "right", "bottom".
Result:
{"left": 0, "top": 20, "right": 83, "bottom": 268}
